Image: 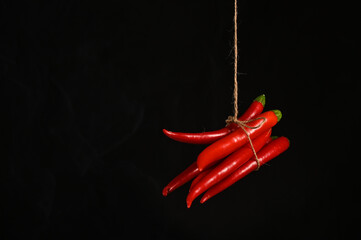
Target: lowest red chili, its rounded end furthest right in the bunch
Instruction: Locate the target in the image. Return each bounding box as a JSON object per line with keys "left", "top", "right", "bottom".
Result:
{"left": 201, "top": 137, "right": 290, "bottom": 203}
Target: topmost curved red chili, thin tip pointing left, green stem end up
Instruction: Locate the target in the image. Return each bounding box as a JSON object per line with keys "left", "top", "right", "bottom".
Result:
{"left": 163, "top": 94, "right": 266, "bottom": 144}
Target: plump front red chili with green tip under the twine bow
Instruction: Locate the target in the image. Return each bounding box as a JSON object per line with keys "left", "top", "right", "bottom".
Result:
{"left": 197, "top": 110, "right": 282, "bottom": 171}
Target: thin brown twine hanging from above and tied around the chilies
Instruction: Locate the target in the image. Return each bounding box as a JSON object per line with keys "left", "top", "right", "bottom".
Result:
{"left": 226, "top": 0, "right": 266, "bottom": 171}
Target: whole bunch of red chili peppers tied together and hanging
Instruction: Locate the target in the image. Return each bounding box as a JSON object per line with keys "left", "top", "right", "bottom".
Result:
{"left": 163, "top": 95, "right": 290, "bottom": 208}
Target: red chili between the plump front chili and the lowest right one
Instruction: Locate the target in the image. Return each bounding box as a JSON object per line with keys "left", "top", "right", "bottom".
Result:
{"left": 187, "top": 129, "right": 272, "bottom": 208}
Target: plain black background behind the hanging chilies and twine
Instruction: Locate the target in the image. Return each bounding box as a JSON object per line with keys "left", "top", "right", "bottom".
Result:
{"left": 0, "top": 0, "right": 361, "bottom": 239}
